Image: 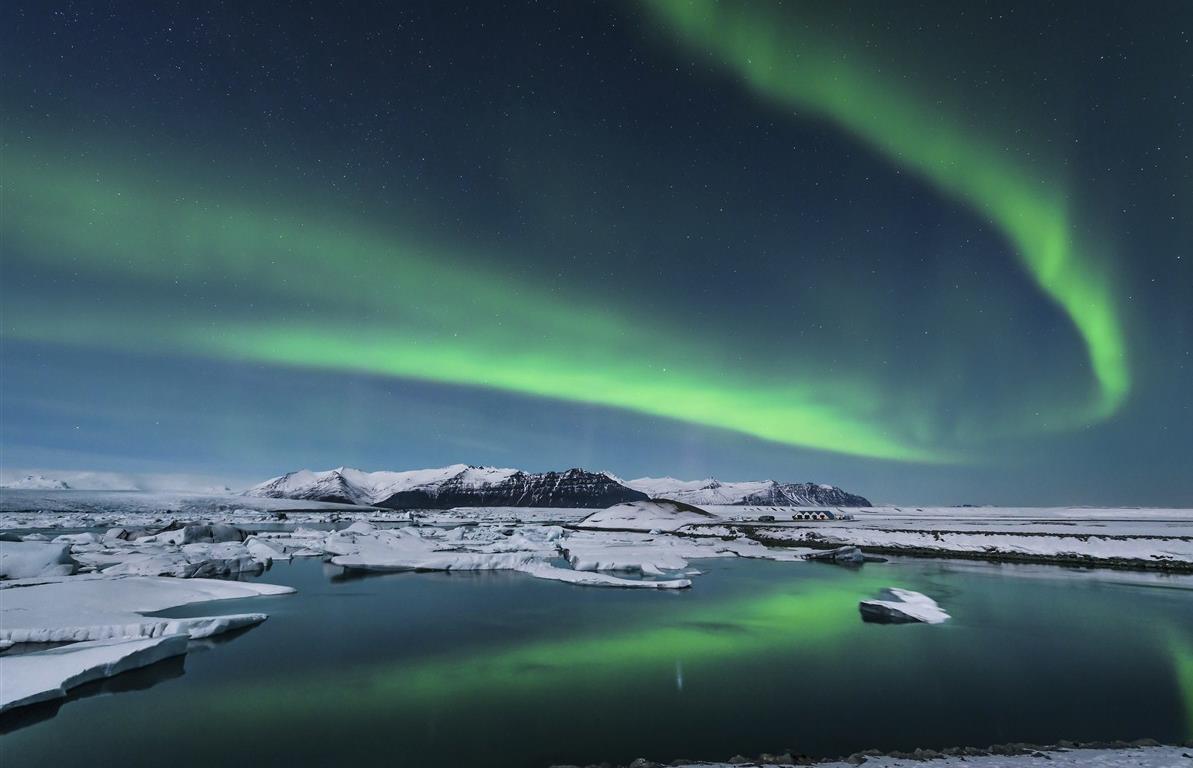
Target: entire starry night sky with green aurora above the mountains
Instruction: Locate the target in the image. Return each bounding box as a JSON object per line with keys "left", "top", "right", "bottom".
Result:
{"left": 0, "top": 0, "right": 1193, "bottom": 506}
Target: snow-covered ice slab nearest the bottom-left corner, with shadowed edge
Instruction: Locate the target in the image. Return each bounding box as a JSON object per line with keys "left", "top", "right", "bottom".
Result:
{"left": 0, "top": 634, "right": 187, "bottom": 712}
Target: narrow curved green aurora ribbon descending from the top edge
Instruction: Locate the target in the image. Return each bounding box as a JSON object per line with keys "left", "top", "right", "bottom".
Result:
{"left": 644, "top": 0, "right": 1131, "bottom": 422}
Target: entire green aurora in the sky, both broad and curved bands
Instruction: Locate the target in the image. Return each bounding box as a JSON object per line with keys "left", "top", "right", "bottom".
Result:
{"left": 0, "top": 1, "right": 1130, "bottom": 463}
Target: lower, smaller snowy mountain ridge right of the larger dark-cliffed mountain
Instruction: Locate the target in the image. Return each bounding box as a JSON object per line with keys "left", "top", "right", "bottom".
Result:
{"left": 622, "top": 477, "right": 872, "bottom": 507}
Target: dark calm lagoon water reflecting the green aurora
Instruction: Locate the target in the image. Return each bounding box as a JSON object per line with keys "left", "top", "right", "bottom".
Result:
{"left": 0, "top": 559, "right": 1193, "bottom": 768}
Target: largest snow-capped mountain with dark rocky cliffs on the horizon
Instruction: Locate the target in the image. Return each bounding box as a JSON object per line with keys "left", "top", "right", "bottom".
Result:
{"left": 245, "top": 464, "right": 647, "bottom": 509}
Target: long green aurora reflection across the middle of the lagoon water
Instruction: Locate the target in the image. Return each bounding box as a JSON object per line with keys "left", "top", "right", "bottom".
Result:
{"left": 212, "top": 572, "right": 888, "bottom": 721}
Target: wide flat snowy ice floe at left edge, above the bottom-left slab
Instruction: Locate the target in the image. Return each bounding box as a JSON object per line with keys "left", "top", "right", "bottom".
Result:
{"left": 0, "top": 576, "right": 293, "bottom": 643}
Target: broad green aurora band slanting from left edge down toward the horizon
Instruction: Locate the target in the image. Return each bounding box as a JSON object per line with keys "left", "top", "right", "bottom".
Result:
{"left": 4, "top": 151, "right": 944, "bottom": 463}
